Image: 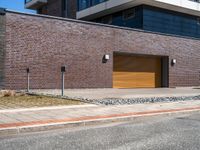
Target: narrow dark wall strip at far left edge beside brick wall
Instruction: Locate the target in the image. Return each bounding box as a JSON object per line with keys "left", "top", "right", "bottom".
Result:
{"left": 0, "top": 14, "right": 5, "bottom": 89}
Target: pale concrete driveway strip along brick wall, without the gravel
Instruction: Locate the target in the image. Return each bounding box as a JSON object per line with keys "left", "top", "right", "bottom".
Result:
{"left": 31, "top": 87, "right": 200, "bottom": 100}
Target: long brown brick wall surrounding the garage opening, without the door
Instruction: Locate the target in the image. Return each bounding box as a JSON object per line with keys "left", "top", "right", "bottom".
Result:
{"left": 5, "top": 12, "right": 200, "bottom": 89}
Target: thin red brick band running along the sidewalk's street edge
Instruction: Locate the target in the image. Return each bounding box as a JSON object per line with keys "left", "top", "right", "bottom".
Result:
{"left": 0, "top": 107, "right": 200, "bottom": 129}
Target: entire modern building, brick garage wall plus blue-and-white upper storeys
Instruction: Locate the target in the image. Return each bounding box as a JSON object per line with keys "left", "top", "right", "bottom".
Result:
{"left": 0, "top": 0, "right": 200, "bottom": 89}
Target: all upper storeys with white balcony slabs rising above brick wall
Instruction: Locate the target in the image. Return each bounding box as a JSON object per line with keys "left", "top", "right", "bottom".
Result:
{"left": 26, "top": 0, "right": 200, "bottom": 38}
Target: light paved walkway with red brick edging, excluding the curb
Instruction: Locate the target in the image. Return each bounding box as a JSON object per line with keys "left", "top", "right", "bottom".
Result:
{"left": 0, "top": 100, "right": 200, "bottom": 130}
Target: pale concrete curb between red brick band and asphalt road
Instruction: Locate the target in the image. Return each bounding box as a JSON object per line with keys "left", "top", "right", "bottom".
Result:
{"left": 0, "top": 107, "right": 200, "bottom": 136}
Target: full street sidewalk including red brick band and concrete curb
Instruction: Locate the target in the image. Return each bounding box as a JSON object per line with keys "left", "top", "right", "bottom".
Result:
{"left": 0, "top": 100, "right": 200, "bottom": 135}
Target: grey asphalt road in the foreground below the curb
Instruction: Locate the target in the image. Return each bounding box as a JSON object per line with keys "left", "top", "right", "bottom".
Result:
{"left": 0, "top": 112, "right": 200, "bottom": 150}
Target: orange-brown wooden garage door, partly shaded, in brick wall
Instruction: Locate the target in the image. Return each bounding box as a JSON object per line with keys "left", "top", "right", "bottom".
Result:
{"left": 113, "top": 55, "right": 161, "bottom": 88}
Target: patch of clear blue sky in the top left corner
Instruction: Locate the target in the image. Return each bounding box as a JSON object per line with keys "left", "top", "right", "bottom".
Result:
{"left": 0, "top": 0, "right": 35, "bottom": 13}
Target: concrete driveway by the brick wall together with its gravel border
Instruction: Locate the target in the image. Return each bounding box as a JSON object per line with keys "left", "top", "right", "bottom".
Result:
{"left": 30, "top": 87, "right": 200, "bottom": 105}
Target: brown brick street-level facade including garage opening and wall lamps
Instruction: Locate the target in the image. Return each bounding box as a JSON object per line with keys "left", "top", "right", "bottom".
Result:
{"left": 0, "top": 11, "right": 200, "bottom": 89}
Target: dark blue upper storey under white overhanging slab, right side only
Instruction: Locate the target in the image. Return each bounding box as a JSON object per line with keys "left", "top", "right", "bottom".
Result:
{"left": 80, "top": 0, "right": 200, "bottom": 38}
